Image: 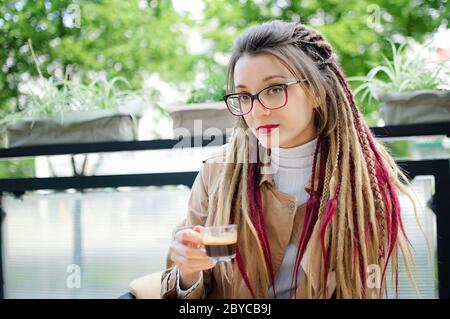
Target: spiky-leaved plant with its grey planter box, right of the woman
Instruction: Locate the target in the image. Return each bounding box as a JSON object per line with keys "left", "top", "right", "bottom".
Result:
{"left": 350, "top": 42, "right": 450, "bottom": 125}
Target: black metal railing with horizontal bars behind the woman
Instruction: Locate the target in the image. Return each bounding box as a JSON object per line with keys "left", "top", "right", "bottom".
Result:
{"left": 0, "top": 123, "right": 450, "bottom": 299}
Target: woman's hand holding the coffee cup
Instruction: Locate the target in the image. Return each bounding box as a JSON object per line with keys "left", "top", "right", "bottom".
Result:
{"left": 170, "top": 225, "right": 216, "bottom": 289}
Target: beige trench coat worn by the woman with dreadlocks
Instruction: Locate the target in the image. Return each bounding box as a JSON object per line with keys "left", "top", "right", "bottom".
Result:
{"left": 130, "top": 144, "right": 336, "bottom": 299}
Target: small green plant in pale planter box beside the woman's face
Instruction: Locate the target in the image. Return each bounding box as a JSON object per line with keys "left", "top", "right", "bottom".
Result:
{"left": 166, "top": 67, "right": 234, "bottom": 136}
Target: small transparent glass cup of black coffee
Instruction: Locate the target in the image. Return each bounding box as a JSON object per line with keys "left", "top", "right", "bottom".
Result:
{"left": 200, "top": 224, "right": 237, "bottom": 262}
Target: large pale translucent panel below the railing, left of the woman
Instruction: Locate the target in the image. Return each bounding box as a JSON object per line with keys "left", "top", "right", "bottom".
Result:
{"left": 4, "top": 188, "right": 189, "bottom": 298}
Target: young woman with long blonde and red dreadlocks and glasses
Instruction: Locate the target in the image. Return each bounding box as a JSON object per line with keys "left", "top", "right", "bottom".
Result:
{"left": 148, "top": 21, "right": 413, "bottom": 298}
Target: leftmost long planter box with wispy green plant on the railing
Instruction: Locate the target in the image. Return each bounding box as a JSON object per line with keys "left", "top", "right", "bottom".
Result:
{"left": 0, "top": 45, "right": 145, "bottom": 147}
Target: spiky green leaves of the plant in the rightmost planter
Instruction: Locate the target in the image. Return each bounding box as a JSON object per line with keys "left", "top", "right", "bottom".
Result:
{"left": 350, "top": 41, "right": 450, "bottom": 101}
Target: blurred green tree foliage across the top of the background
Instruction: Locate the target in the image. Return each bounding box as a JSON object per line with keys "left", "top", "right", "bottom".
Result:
{"left": 0, "top": 0, "right": 449, "bottom": 124}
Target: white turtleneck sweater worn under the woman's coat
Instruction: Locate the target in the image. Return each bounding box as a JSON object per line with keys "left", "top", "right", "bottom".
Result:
{"left": 177, "top": 138, "right": 317, "bottom": 299}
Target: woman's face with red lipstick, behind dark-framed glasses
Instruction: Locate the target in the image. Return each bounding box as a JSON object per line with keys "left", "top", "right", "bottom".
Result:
{"left": 234, "top": 54, "right": 317, "bottom": 148}
